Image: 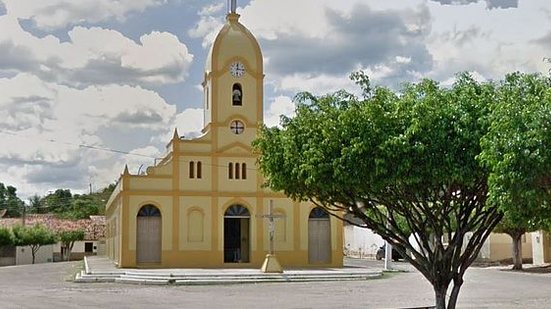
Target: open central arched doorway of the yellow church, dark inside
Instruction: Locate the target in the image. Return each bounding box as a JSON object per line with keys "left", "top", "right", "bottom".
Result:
{"left": 224, "top": 205, "right": 251, "bottom": 263}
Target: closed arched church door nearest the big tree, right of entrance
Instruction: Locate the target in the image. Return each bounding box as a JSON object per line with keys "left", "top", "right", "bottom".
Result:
{"left": 308, "top": 207, "right": 331, "bottom": 264}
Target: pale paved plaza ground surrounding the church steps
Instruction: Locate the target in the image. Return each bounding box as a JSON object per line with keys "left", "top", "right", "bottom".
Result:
{"left": 0, "top": 260, "right": 551, "bottom": 309}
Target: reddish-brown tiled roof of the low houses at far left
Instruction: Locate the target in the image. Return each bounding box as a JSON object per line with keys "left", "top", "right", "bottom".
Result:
{"left": 0, "top": 214, "right": 105, "bottom": 240}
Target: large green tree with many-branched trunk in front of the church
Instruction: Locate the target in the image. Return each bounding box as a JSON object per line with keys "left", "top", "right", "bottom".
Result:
{"left": 254, "top": 73, "right": 502, "bottom": 308}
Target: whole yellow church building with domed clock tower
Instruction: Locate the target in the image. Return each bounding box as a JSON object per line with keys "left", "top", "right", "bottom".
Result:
{"left": 105, "top": 1, "right": 343, "bottom": 268}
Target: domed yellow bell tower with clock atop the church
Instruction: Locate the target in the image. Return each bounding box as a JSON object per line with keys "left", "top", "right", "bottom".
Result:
{"left": 202, "top": 0, "right": 264, "bottom": 148}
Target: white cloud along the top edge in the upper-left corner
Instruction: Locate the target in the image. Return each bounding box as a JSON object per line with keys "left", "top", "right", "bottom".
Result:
{"left": 3, "top": 0, "right": 166, "bottom": 30}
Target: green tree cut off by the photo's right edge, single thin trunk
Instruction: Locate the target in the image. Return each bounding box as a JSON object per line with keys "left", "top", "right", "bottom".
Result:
{"left": 480, "top": 73, "right": 551, "bottom": 269}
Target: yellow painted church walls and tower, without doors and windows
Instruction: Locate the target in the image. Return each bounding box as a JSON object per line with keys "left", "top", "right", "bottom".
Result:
{"left": 106, "top": 14, "right": 343, "bottom": 268}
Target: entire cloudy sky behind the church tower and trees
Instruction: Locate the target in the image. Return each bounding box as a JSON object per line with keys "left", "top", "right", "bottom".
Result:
{"left": 0, "top": 0, "right": 551, "bottom": 199}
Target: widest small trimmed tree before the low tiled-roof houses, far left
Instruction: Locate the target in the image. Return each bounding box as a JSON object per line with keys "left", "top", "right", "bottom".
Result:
{"left": 13, "top": 224, "right": 56, "bottom": 264}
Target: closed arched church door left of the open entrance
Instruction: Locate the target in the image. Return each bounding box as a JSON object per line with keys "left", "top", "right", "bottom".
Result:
{"left": 136, "top": 205, "right": 162, "bottom": 264}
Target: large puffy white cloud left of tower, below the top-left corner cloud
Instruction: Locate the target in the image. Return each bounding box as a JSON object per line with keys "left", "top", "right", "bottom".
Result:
{"left": 0, "top": 16, "right": 193, "bottom": 87}
